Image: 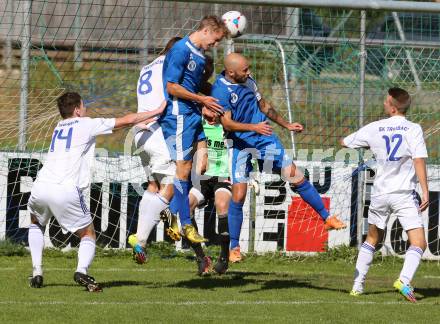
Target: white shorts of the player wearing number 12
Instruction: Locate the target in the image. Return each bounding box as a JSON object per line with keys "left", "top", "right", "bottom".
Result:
{"left": 368, "top": 191, "right": 423, "bottom": 231}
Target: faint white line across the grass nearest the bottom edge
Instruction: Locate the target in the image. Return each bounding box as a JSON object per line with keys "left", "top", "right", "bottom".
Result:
{"left": 0, "top": 300, "right": 438, "bottom": 306}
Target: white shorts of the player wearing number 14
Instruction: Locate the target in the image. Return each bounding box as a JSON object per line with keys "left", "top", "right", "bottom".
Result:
{"left": 27, "top": 181, "right": 92, "bottom": 233}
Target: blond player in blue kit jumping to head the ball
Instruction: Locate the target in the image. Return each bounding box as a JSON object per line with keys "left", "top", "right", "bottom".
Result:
{"left": 153, "top": 16, "right": 227, "bottom": 247}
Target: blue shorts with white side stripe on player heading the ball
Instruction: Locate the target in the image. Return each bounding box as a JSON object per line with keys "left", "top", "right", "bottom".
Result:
{"left": 159, "top": 107, "right": 205, "bottom": 161}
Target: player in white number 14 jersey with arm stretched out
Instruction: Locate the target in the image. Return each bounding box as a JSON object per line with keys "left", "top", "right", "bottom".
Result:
{"left": 28, "top": 92, "right": 163, "bottom": 291}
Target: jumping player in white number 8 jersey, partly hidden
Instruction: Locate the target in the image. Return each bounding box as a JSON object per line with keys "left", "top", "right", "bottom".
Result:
{"left": 128, "top": 37, "right": 182, "bottom": 264}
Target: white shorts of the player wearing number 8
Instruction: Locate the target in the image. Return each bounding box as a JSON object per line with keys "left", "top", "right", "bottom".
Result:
{"left": 134, "top": 123, "right": 176, "bottom": 183}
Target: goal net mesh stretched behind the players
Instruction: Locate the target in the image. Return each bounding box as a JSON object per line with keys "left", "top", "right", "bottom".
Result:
{"left": 0, "top": 0, "right": 440, "bottom": 256}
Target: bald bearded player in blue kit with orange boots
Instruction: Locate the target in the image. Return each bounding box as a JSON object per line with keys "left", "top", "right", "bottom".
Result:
{"left": 211, "top": 53, "right": 346, "bottom": 262}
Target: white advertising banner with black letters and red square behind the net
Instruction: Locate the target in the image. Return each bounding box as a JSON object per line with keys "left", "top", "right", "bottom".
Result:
{"left": 0, "top": 152, "right": 440, "bottom": 259}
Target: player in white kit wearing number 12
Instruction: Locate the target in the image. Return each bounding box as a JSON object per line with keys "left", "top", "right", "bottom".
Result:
{"left": 341, "top": 88, "right": 429, "bottom": 302}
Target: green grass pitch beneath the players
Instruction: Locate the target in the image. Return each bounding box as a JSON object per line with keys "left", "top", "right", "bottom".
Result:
{"left": 0, "top": 246, "right": 440, "bottom": 323}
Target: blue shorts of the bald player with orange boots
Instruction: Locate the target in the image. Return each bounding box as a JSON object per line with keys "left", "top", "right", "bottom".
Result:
{"left": 229, "top": 135, "right": 293, "bottom": 183}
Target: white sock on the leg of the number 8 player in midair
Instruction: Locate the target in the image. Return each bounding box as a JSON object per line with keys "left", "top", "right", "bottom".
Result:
{"left": 136, "top": 191, "right": 168, "bottom": 247}
